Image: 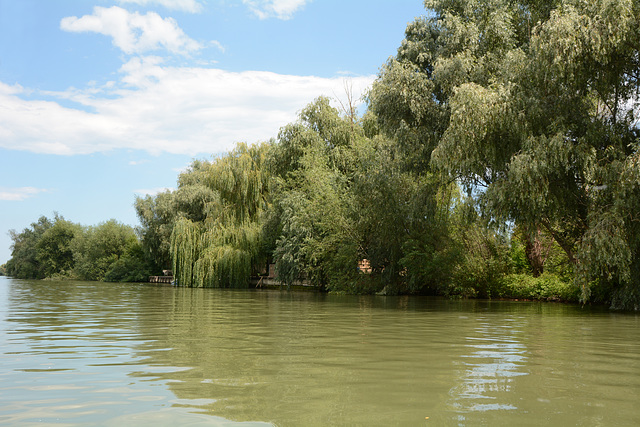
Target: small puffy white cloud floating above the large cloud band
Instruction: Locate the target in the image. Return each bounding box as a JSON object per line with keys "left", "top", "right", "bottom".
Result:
{"left": 60, "top": 6, "right": 202, "bottom": 55}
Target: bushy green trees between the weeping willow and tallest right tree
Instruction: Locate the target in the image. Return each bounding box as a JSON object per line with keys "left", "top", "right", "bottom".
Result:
{"left": 271, "top": 98, "right": 455, "bottom": 294}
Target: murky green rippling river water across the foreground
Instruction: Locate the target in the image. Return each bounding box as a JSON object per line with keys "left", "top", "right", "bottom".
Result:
{"left": 0, "top": 277, "right": 640, "bottom": 426}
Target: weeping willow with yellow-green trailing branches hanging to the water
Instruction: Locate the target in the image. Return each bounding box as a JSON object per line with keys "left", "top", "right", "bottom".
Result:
{"left": 171, "top": 144, "right": 270, "bottom": 287}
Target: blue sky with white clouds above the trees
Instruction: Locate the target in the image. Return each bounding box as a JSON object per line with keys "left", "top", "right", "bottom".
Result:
{"left": 0, "top": 0, "right": 426, "bottom": 264}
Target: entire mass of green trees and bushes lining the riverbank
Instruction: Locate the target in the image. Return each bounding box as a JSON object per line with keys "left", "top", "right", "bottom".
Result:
{"left": 2, "top": 0, "right": 640, "bottom": 309}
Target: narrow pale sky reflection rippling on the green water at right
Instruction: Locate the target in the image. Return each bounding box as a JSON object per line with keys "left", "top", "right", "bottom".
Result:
{"left": 450, "top": 318, "right": 527, "bottom": 421}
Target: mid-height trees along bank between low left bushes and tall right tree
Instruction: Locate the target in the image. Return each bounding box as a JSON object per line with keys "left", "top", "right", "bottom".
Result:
{"left": 136, "top": 98, "right": 579, "bottom": 301}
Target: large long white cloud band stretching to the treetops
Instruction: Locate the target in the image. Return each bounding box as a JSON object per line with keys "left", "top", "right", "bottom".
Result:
{"left": 0, "top": 63, "right": 375, "bottom": 156}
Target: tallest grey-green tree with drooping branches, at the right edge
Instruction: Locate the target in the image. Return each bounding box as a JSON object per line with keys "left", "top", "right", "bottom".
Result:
{"left": 370, "top": 0, "right": 640, "bottom": 308}
